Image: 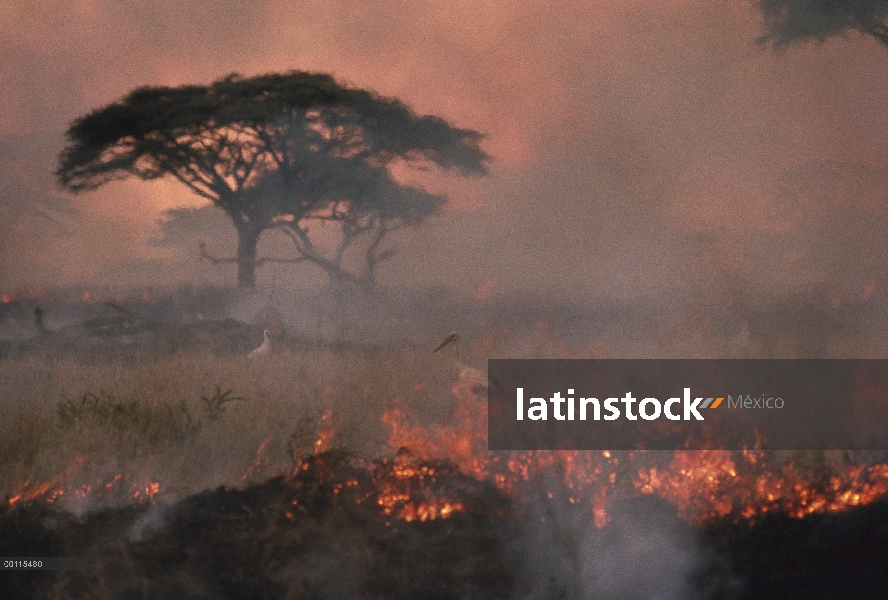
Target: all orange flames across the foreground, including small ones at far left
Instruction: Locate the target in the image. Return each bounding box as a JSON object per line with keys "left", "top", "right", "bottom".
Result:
{"left": 7, "top": 370, "right": 888, "bottom": 527}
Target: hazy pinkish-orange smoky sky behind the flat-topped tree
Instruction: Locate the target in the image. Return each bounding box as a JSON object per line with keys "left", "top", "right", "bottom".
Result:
{"left": 0, "top": 0, "right": 888, "bottom": 302}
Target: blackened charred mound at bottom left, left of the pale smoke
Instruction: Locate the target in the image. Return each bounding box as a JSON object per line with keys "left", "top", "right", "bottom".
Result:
{"left": 0, "top": 450, "right": 518, "bottom": 598}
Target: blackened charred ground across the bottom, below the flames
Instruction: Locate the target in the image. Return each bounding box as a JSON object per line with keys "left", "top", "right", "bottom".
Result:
{"left": 0, "top": 450, "right": 888, "bottom": 599}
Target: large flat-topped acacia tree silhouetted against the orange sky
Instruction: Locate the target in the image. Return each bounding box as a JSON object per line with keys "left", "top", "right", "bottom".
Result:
{"left": 57, "top": 71, "right": 489, "bottom": 288}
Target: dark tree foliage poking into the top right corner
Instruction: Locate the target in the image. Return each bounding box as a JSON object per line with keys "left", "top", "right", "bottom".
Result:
{"left": 758, "top": 0, "right": 888, "bottom": 47}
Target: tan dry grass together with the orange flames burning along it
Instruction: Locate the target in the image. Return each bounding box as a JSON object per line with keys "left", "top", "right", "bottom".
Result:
{"left": 0, "top": 348, "right": 888, "bottom": 527}
